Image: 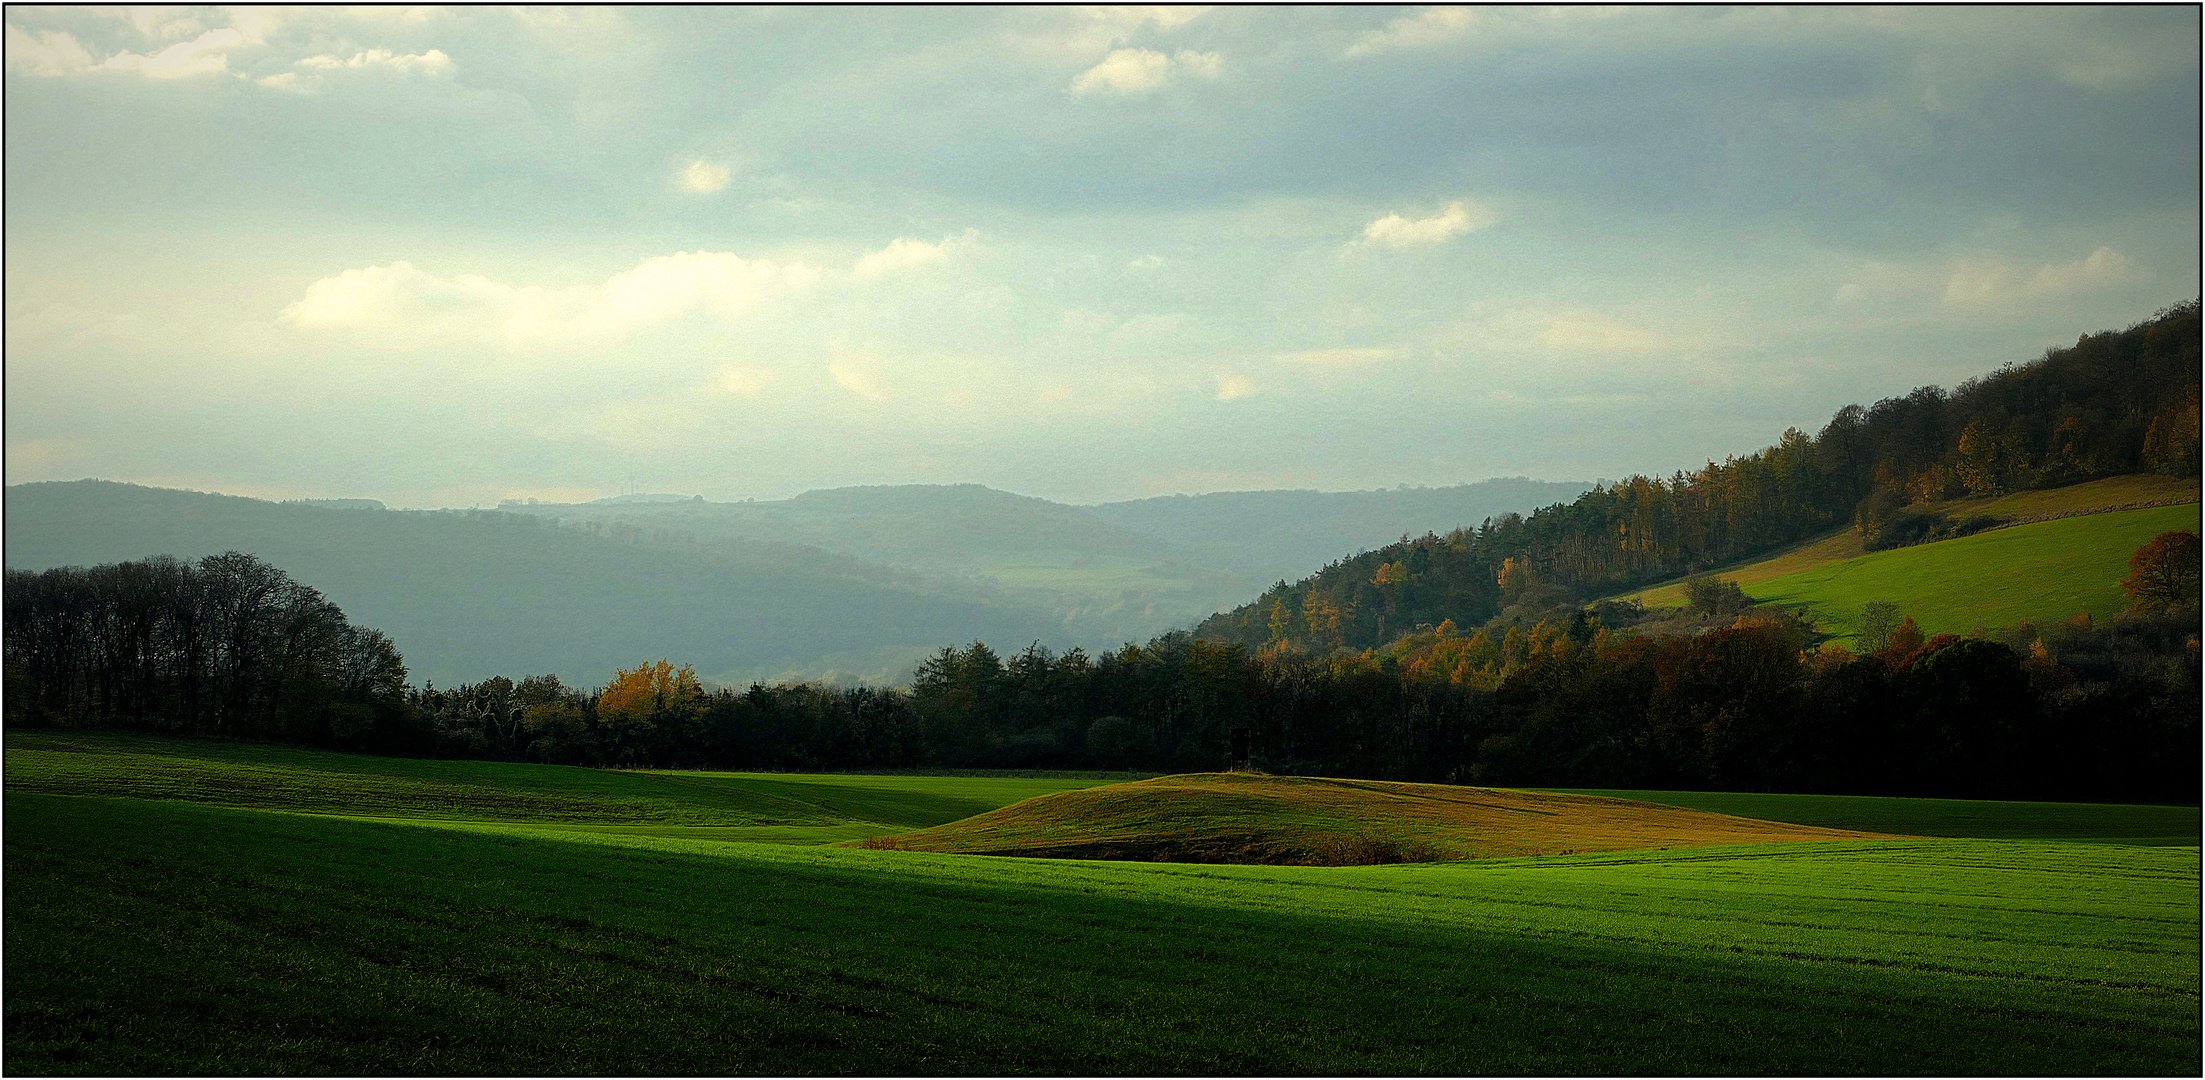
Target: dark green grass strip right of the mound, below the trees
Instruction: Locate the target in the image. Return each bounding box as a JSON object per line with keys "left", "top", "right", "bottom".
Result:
{"left": 1550, "top": 787, "right": 2201, "bottom": 846}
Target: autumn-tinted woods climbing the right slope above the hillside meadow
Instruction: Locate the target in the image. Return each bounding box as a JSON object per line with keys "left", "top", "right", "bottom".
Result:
{"left": 1197, "top": 300, "right": 2198, "bottom": 655}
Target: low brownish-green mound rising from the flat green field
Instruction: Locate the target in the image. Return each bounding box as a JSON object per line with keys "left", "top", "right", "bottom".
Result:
{"left": 853, "top": 774, "right": 1879, "bottom": 866}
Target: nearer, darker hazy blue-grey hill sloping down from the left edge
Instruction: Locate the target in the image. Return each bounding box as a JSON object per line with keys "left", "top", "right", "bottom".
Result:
{"left": 7, "top": 480, "right": 1056, "bottom": 685}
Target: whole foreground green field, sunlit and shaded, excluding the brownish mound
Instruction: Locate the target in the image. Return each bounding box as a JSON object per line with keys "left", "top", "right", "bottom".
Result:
{"left": 4, "top": 734, "right": 2201, "bottom": 1076}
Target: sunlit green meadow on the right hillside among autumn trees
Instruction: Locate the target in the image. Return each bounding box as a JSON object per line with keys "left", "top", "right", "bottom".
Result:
{"left": 1638, "top": 503, "right": 2198, "bottom": 644}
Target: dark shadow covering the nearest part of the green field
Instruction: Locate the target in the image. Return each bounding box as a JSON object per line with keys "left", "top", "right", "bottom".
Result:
{"left": 4, "top": 796, "right": 2198, "bottom": 1076}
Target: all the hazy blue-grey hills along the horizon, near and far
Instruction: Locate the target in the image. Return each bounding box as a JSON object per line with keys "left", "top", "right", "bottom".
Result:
{"left": 7, "top": 480, "right": 1587, "bottom": 683}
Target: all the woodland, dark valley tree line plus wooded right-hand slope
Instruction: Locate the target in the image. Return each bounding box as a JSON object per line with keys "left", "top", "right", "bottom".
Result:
{"left": 4, "top": 302, "right": 2198, "bottom": 802}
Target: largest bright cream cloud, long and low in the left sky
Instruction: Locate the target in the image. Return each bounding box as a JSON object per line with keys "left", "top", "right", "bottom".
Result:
{"left": 278, "top": 251, "right": 818, "bottom": 344}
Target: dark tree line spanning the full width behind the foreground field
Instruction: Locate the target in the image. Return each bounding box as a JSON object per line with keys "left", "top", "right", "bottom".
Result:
{"left": 7, "top": 544, "right": 2201, "bottom": 800}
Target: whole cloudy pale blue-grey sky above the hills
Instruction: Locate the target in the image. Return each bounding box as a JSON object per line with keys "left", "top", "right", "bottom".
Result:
{"left": 0, "top": 7, "right": 2201, "bottom": 507}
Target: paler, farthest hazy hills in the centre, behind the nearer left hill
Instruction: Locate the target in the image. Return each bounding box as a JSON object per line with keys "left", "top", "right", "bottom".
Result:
{"left": 501, "top": 478, "right": 1588, "bottom": 648}
